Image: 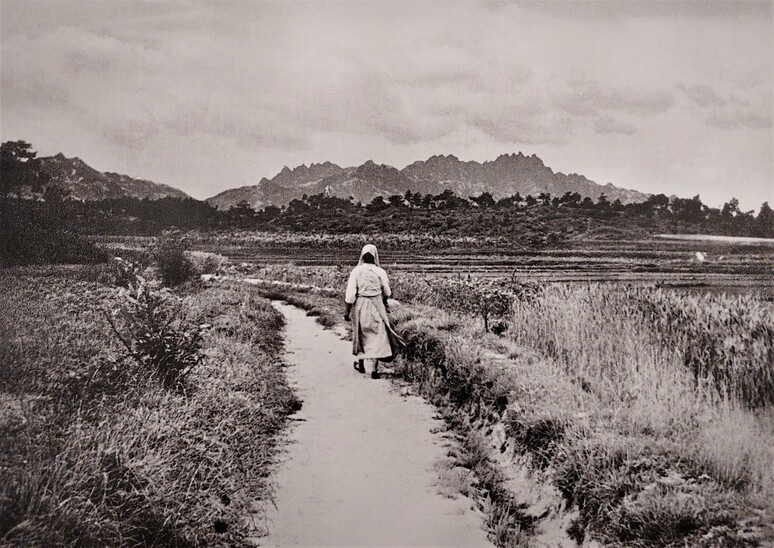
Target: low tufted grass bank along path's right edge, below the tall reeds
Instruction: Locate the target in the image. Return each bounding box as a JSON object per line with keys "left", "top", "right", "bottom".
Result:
{"left": 244, "top": 276, "right": 774, "bottom": 546}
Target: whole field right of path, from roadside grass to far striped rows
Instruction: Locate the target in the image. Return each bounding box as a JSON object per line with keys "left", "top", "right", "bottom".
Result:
{"left": 209, "top": 233, "right": 774, "bottom": 546}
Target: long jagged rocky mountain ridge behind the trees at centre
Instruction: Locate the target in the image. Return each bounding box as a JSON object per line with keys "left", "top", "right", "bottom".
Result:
{"left": 206, "top": 152, "right": 648, "bottom": 209}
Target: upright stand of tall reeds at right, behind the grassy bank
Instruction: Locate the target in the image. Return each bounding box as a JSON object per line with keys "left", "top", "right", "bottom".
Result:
{"left": 511, "top": 284, "right": 774, "bottom": 409}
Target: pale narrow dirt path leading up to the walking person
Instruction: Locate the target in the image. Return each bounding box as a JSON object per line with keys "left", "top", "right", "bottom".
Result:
{"left": 260, "top": 304, "right": 491, "bottom": 546}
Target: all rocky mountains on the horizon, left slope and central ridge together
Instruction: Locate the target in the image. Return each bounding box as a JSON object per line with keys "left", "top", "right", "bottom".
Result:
{"left": 21, "top": 152, "right": 648, "bottom": 210}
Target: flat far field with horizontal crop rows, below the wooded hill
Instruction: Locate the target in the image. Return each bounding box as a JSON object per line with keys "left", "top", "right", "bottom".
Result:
{"left": 147, "top": 232, "right": 774, "bottom": 301}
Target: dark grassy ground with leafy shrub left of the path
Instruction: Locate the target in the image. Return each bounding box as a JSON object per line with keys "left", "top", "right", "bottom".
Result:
{"left": 0, "top": 266, "right": 297, "bottom": 546}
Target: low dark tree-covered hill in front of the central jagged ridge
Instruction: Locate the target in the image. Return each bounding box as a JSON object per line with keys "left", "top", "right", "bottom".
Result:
{"left": 242, "top": 190, "right": 774, "bottom": 237}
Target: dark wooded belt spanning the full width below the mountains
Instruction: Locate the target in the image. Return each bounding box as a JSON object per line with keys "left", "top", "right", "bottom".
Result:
{"left": 0, "top": 141, "right": 774, "bottom": 264}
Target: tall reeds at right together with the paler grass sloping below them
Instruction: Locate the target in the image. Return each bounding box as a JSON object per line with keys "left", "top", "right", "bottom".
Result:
{"left": 510, "top": 285, "right": 774, "bottom": 500}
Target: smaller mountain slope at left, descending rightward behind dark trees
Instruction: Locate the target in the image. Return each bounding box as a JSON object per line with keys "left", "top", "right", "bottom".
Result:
{"left": 40, "top": 153, "right": 190, "bottom": 201}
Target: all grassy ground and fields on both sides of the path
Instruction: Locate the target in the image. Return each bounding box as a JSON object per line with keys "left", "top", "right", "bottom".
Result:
{"left": 6, "top": 232, "right": 774, "bottom": 546}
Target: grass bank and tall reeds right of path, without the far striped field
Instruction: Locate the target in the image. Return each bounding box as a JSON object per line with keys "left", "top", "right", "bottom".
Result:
{"left": 249, "top": 267, "right": 774, "bottom": 546}
